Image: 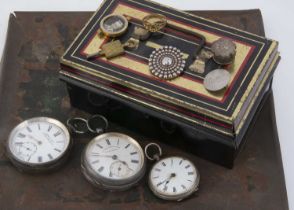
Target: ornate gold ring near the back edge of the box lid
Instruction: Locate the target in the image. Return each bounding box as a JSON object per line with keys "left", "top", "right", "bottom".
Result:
{"left": 142, "top": 14, "right": 167, "bottom": 33}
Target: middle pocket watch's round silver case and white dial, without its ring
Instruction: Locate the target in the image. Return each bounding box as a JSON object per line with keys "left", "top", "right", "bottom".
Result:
{"left": 81, "top": 132, "right": 146, "bottom": 191}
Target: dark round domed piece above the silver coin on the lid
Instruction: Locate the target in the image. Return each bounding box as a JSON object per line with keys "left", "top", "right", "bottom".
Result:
{"left": 211, "top": 38, "right": 236, "bottom": 65}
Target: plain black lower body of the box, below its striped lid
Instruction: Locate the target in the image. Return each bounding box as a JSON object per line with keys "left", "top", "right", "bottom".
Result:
{"left": 67, "top": 76, "right": 271, "bottom": 168}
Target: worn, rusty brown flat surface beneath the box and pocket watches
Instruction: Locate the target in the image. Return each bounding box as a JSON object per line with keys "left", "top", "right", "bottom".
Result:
{"left": 0, "top": 10, "right": 288, "bottom": 210}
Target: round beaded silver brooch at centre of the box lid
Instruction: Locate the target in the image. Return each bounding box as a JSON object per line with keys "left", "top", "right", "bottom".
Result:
{"left": 149, "top": 46, "right": 186, "bottom": 80}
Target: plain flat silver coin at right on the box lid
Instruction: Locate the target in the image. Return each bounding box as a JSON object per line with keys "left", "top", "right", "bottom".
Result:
{"left": 203, "top": 69, "right": 231, "bottom": 92}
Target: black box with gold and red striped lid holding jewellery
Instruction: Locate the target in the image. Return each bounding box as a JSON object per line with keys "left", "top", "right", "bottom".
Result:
{"left": 60, "top": 0, "right": 280, "bottom": 167}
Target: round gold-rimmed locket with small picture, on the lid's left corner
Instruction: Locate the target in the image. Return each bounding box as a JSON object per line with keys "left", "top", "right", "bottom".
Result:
{"left": 100, "top": 14, "right": 129, "bottom": 37}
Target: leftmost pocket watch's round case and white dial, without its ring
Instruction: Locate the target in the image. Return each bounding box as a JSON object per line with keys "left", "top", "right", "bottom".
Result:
{"left": 6, "top": 117, "right": 72, "bottom": 172}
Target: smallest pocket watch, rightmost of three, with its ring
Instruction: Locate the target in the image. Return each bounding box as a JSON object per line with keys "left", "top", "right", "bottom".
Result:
{"left": 145, "top": 143, "right": 200, "bottom": 201}
